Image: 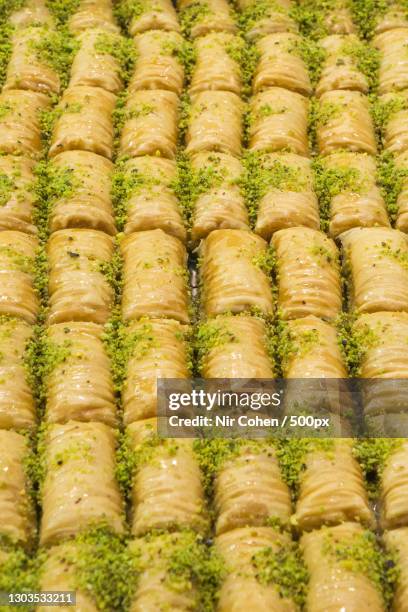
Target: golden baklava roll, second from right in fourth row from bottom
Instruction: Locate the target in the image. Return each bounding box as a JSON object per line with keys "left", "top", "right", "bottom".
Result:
{"left": 272, "top": 227, "right": 342, "bottom": 320}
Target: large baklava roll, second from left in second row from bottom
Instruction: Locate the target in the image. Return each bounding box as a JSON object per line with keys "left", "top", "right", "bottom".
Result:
{"left": 40, "top": 421, "right": 124, "bottom": 546}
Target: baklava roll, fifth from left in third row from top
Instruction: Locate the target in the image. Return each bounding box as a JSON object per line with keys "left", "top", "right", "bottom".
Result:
{"left": 249, "top": 87, "right": 309, "bottom": 157}
